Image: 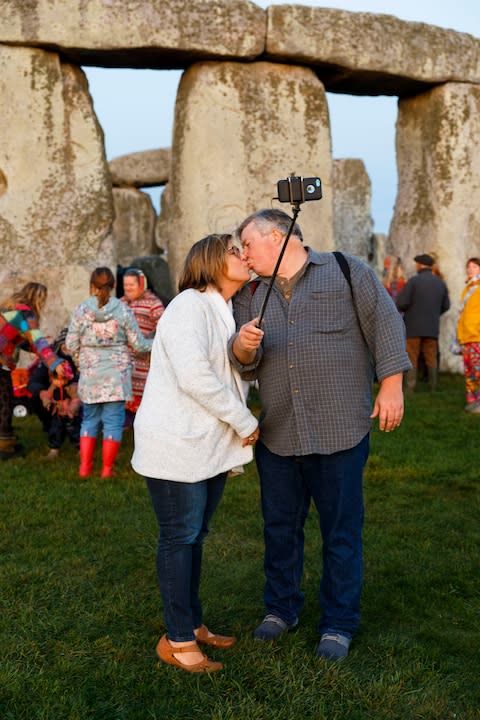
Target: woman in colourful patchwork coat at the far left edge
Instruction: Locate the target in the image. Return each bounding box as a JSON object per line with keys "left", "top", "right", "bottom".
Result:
{"left": 0, "top": 282, "right": 73, "bottom": 460}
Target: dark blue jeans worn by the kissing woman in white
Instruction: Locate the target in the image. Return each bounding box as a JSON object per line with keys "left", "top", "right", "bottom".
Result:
{"left": 145, "top": 473, "right": 227, "bottom": 642}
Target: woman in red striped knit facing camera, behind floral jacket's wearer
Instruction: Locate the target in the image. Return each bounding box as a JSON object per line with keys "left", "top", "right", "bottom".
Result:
{"left": 121, "top": 268, "right": 165, "bottom": 427}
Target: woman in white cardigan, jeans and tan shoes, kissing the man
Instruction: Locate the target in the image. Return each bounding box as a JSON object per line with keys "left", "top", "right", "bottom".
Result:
{"left": 132, "top": 235, "right": 258, "bottom": 672}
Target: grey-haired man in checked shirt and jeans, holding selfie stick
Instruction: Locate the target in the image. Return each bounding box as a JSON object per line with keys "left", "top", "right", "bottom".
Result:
{"left": 230, "top": 210, "right": 410, "bottom": 660}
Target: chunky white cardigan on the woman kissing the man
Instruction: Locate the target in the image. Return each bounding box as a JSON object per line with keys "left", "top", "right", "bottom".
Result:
{"left": 132, "top": 289, "right": 258, "bottom": 482}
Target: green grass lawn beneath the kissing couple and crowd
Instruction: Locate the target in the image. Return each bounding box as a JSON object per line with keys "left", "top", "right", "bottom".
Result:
{"left": 0, "top": 376, "right": 480, "bottom": 720}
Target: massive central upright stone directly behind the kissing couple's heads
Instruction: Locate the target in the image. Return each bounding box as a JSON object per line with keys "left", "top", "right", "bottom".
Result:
{"left": 157, "top": 62, "right": 333, "bottom": 286}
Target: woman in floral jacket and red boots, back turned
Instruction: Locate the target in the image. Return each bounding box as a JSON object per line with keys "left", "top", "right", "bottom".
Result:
{"left": 65, "top": 267, "right": 152, "bottom": 478}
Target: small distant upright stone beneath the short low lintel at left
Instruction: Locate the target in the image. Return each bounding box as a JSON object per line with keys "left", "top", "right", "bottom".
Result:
{"left": 113, "top": 188, "right": 156, "bottom": 265}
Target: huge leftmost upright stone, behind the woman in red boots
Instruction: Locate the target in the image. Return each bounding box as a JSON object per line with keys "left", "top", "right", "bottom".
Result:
{"left": 0, "top": 46, "right": 115, "bottom": 334}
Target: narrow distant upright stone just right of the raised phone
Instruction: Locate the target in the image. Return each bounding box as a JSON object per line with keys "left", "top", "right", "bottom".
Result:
{"left": 332, "top": 159, "right": 373, "bottom": 262}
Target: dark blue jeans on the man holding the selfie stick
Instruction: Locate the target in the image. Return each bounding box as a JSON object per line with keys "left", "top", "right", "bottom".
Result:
{"left": 255, "top": 435, "right": 369, "bottom": 637}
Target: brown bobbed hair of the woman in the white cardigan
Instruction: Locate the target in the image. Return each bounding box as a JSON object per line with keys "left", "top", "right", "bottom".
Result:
{"left": 178, "top": 233, "right": 233, "bottom": 292}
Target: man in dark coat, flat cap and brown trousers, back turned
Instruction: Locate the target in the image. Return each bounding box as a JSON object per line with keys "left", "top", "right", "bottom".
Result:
{"left": 397, "top": 255, "right": 450, "bottom": 392}
